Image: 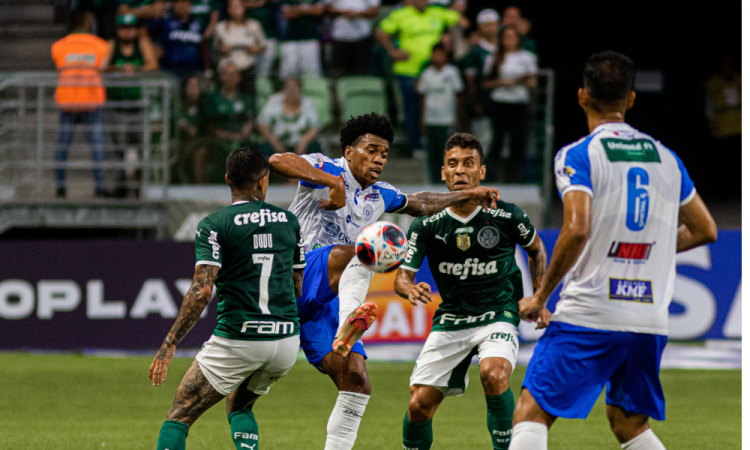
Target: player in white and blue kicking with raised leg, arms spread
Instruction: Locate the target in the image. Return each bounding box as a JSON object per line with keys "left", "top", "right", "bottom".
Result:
{"left": 270, "top": 113, "right": 500, "bottom": 450}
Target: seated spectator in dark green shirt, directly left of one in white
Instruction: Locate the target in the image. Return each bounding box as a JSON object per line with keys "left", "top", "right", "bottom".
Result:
{"left": 193, "top": 61, "right": 253, "bottom": 183}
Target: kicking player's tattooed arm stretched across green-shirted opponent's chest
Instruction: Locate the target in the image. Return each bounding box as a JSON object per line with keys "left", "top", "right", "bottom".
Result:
{"left": 398, "top": 186, "right": 500, "bottom": 217}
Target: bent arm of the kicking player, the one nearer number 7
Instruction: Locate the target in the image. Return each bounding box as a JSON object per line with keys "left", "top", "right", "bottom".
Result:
{"left": 268, "top": 153, "right": 346, "bottom": 211}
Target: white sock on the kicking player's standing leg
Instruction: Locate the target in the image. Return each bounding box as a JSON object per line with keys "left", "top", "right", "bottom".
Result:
{"left": 325, "top": 391, "right": 370, "bottom": 450}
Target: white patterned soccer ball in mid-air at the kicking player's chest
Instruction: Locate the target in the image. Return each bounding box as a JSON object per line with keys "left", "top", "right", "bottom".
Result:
{"left": 354, "top": 222, "right": 406, "bottom": 273}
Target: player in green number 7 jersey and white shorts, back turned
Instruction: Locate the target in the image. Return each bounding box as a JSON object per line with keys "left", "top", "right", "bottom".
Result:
{"left": 149, "top": 148, "right": 305, "bottom": 450}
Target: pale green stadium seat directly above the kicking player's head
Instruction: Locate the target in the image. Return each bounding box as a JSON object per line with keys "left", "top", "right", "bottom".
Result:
{"left": 336, "top": 76, "right": 388, "bottom": 123}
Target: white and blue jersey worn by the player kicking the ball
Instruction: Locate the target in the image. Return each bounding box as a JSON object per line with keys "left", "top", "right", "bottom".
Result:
{"left": 289, "top": 153, "right": 407, "bottom": 251}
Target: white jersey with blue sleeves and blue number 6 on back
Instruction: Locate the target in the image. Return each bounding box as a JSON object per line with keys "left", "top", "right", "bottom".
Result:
{"left": 552, "top": 123, "right": 695, "bottom": 335}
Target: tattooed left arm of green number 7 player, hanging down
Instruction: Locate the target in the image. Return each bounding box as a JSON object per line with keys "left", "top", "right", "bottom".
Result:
{"left": 148, "top": 264, "right": 219, "bottom": 386}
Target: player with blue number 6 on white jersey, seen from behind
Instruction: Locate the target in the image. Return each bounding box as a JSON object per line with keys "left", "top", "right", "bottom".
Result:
{"left": 510, "top": 52, "right": 716, "bottom": 450}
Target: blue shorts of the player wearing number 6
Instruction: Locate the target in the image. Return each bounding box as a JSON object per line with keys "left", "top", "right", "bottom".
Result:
{"left": 523, "top": 322, "right": 667, "bottom": 420}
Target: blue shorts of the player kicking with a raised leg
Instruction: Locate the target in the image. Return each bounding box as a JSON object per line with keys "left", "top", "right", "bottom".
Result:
{"left": 297, "top": 245, "right": 367, "bottom": 373}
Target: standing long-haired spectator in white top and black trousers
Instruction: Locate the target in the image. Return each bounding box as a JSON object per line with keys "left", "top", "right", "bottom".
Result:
{"left": 482, "top": 26, "right": 538, "bottom": 183}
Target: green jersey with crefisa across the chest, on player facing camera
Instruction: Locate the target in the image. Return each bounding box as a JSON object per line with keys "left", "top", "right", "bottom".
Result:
{"left": 400, "top": 201, "right": 536, "bottom": 331}
